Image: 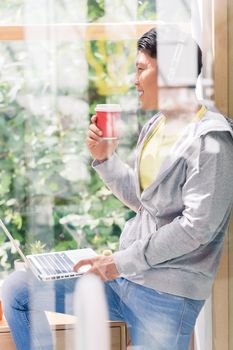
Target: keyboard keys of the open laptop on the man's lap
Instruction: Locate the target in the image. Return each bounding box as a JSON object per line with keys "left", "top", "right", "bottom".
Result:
{"left": 31, "top": 253, "right": 74, "bottom": 276}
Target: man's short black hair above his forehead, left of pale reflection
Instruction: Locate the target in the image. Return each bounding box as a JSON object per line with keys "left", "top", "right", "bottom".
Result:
{"left": 137, "top": 28, "right": 157, "bottom": 58}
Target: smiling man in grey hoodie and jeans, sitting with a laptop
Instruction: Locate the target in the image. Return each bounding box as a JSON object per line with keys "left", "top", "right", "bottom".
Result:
{"left": 3, "top": 29, "right": 233, "bottom": 350}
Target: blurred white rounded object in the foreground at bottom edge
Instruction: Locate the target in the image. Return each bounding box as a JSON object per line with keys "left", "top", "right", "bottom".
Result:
{"left": 74, "top": 274, "right": 110, "bottom": 350}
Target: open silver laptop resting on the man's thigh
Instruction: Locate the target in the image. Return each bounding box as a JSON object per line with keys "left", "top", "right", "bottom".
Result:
{"left": 0, "top": 219, "right": 97, "bottom": 281}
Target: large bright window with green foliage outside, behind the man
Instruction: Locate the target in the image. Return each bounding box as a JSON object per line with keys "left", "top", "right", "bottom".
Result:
{"left": 0, "top": 0, "right": 230, "bottom": 350}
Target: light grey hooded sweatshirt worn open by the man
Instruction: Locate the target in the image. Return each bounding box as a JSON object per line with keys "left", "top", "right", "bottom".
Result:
{"left": 93, "top": 111, "right": 233, "bottom": 300}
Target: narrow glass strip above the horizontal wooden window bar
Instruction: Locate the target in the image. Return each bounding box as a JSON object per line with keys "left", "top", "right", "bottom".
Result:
{"left": 0, "top": 0, "right": 156, "bottom": 25}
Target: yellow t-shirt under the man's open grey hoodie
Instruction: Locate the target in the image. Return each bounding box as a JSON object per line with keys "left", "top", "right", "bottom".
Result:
{"left": 139, "top": 106, "right": 206, "bottom": 191}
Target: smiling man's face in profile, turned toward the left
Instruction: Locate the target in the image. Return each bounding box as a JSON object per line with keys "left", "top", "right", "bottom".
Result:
{"left": 134, "top": 51, "right": 158, "bottom": 110}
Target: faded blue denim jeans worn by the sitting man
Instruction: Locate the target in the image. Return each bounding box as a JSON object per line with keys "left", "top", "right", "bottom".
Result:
{"left": 2, "top": 271, "right": 204, "bottom": 350}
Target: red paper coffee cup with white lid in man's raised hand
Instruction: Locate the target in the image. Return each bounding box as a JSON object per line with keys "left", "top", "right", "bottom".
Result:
{"left": 95, "top": 104, "right": 121, "bottom": 140}
